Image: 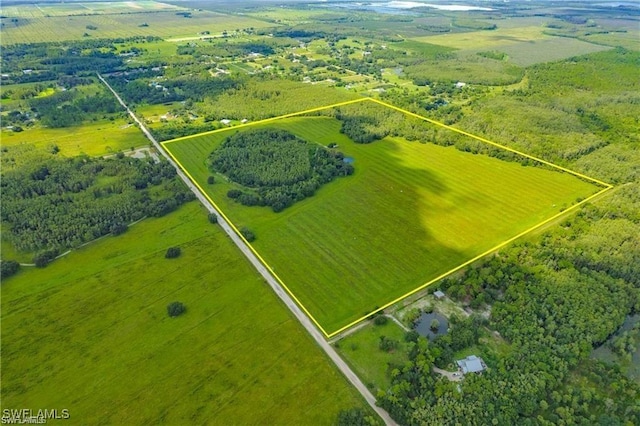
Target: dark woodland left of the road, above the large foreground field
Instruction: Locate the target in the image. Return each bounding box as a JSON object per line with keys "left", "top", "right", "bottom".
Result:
{"left": 0, "top": 151, "right": 193, "bottom": 262}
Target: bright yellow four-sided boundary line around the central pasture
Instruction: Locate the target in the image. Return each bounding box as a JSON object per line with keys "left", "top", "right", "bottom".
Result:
{"left": 160, "top": 98, "right": 613, "bottom": 339}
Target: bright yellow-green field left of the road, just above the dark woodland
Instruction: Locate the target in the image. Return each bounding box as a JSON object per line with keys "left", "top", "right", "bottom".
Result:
{"left": 0, "top": 119, "right": 149, "bottom": 156}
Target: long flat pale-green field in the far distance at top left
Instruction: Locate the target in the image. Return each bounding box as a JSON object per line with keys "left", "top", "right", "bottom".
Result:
{"left": 1, "top": 6, "right": 273, "bottom": 45}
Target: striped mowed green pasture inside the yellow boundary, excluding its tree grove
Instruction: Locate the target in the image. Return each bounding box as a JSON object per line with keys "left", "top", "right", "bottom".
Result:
{"left": 165, "top": 108, "right": 602, "bottom": 334}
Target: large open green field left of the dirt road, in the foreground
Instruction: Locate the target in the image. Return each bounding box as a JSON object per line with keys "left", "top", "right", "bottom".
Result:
{"left": 1, "top": 202, "right": 365, "bottom": 425}
